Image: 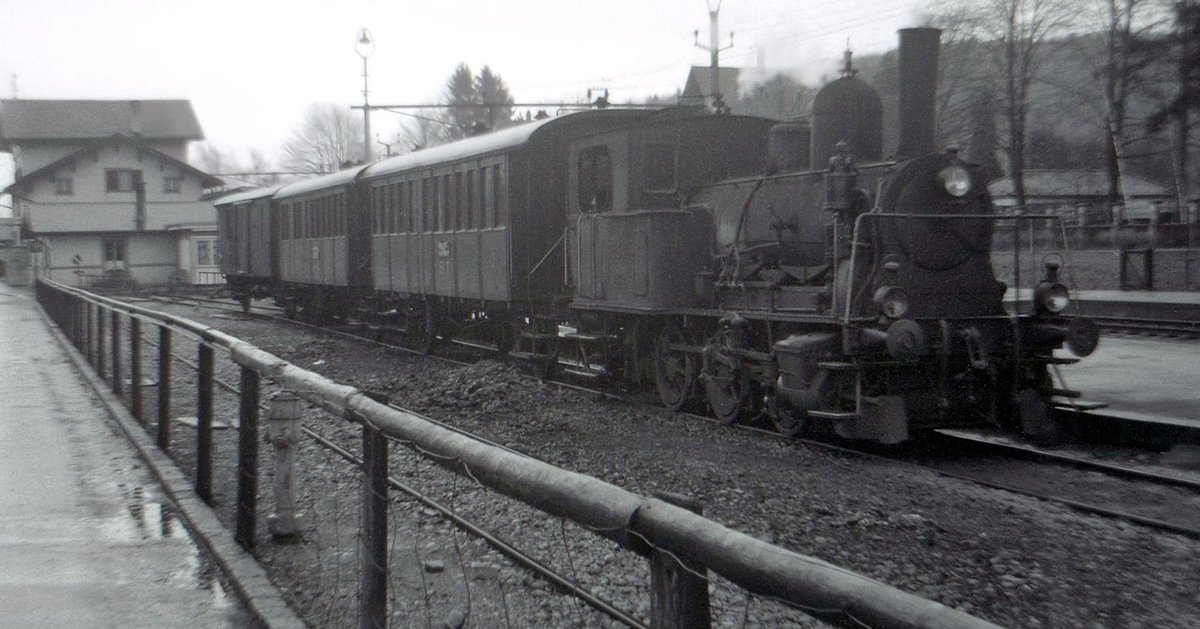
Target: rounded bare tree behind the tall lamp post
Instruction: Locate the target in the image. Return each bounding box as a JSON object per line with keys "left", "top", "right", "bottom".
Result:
{"left": 283, "top": 103, "right": 362, "bottom": 174}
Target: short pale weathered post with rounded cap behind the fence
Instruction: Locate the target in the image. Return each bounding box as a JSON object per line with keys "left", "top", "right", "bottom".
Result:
{"left": 266, "top": 391, "right": 301, "bottom": 539}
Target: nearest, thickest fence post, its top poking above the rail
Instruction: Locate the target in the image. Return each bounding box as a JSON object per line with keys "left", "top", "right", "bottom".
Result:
{"left": 650, "top": 491, "right": 713, "bottom": 629}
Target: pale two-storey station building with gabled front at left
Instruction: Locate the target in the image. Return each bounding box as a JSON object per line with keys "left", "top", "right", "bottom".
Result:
{"left": 0, "top": 100, "right": 221, "bottom": 286}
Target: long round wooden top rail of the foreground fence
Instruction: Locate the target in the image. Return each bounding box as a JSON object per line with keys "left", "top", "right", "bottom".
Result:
{"left": 41, "top": 280, "right": 996, "bottom": 628}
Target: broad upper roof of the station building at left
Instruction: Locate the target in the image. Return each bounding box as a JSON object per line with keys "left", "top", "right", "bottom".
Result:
{"left": 0, "top": 100, "right": 204, "bottom": 142}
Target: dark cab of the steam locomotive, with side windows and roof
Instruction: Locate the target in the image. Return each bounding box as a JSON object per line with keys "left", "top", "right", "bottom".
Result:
{"left": 568, "top": 108, "right": 772, "bottom": 312}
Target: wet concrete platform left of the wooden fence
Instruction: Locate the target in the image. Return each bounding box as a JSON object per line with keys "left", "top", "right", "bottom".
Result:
{"left": 0, "top": 283, "right": 253, "bottom": 628}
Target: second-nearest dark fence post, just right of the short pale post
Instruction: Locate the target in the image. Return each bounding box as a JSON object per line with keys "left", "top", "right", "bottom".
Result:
{"left": 359, "top": 421, "right": 388, "bottom": 629}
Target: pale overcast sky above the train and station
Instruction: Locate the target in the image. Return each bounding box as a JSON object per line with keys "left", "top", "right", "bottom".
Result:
{"left": 0, "top": 0, "right": 922, "bottom": 166}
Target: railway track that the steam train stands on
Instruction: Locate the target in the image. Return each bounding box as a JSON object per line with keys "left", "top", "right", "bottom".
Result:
{"left": 150, "top": 295, "right": 1200, "bottom": 540}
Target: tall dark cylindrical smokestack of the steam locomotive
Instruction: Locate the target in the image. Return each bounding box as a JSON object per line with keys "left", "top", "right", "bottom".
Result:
{"left": 896, "top": 28, "right": 942, "bottom": 158}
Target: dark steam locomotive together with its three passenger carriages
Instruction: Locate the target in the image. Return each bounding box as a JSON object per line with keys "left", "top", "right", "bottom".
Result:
{"left": 217, "top": 29, "right": 1098, "bottom": 443}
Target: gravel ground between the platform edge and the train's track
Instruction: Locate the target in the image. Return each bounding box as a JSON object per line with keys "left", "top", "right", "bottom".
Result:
{"left": 142, "top": 306, "right": 1200, "bottom": 628}
